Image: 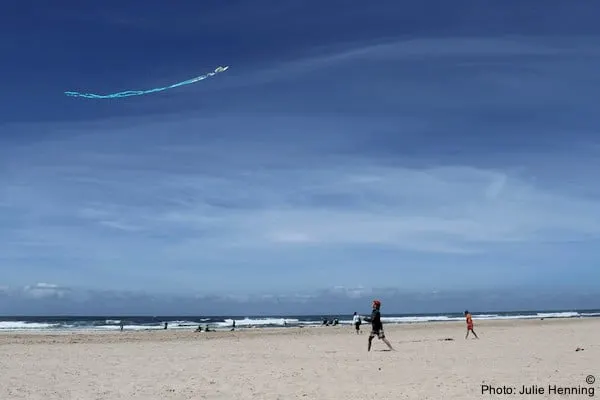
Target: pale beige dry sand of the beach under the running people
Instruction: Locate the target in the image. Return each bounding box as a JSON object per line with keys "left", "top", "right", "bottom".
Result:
{"left": 0, "top": 319, "right": 600, "bottom": 400}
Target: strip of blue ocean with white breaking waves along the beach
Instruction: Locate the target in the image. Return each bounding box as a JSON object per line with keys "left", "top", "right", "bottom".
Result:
{"left": 0, "top": 310, "right": 600, "bottom": 333}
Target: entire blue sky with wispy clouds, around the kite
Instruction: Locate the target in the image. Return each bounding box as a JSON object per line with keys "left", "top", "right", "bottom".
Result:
{"left": 0, "top": 0, "right": 600, "bottom": 313}
